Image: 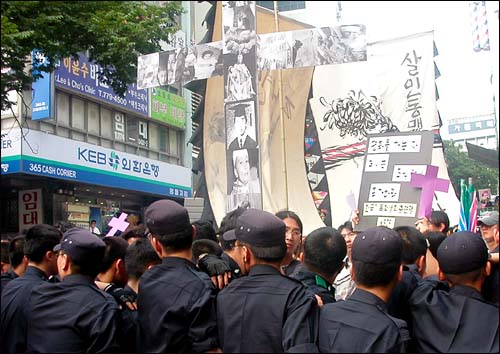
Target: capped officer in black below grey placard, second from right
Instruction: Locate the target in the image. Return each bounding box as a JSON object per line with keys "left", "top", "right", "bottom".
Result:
{"left": 319, "top": 227, "right": 410, "bottom": 353}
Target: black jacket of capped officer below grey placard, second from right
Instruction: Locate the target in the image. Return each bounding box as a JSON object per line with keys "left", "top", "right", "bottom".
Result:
{"left": 319, "top": 289, "right": 410, "bottom": 353}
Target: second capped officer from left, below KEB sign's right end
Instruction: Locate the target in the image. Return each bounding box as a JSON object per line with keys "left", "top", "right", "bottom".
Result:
{"left": 137, "top": 200, "right": 219, "bottom": 353}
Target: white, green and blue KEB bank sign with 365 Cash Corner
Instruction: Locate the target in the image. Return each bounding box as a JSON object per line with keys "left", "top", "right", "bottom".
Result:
{"left": 21, "top": 130, "right": 192, "bottom": 198}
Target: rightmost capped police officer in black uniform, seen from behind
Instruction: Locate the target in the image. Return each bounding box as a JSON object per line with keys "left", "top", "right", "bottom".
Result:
{"left": 410, "top": 231, "right": 500, "bottom": 353}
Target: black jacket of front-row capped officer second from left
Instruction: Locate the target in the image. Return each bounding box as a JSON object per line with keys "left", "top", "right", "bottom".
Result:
{"left": 137, "top": 257, "right": 218, "bottom": 353}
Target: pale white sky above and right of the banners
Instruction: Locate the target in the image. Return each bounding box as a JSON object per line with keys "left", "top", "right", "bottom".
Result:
{"left": 282, "top": 1, "right": 498, "bottom": 121}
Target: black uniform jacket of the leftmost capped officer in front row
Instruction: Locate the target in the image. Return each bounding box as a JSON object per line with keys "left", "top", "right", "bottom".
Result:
{"left": 28, "top": 274, "right": 119, "bottom": 353}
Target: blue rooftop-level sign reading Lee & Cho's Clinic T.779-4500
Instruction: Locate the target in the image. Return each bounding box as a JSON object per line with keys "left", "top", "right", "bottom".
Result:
{"left": 54, "top": 53, "right": 149, "bottom": 117}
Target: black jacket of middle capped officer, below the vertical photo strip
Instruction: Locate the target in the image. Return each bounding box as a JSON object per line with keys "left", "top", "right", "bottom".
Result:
{"left": 217, "top": 265, "right": 318, "bottom": 353}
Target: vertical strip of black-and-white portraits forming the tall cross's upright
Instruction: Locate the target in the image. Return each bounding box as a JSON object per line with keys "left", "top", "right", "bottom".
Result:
{"left": 222, "top": 1, "right": 262, "bottom": 212}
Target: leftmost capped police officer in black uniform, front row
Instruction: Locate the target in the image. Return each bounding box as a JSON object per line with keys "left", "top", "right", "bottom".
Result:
{"left": 28, "top": 228, "right": 118, "bottom": 353}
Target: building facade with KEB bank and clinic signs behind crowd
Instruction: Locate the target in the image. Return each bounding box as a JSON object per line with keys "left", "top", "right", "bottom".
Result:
{"left": 0, "top": 2, "right": 192, "bottom": 238}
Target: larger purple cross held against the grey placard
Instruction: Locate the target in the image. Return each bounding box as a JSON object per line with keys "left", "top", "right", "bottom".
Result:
{"left": 410, "top": 165, "right": 450, "bottom": 218}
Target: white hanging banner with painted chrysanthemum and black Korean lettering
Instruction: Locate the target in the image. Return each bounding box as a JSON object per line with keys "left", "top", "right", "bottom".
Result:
{"left": 310, "top": 32, "right": 458, "bottom": 226}
